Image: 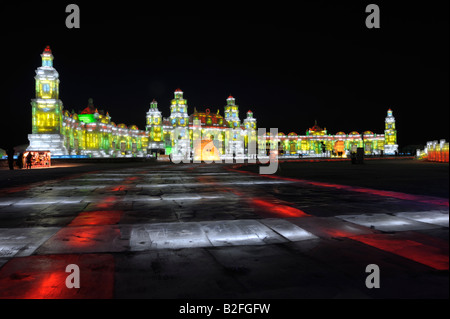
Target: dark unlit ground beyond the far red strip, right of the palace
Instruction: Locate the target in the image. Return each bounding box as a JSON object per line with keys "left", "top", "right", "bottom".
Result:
{"left": 243, "top": 157, "right": 449, "bottom": 198}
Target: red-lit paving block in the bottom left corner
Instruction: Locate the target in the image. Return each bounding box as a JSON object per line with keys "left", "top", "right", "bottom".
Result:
{"left": 0, "top": 254, "right": 114, "bottom": 299}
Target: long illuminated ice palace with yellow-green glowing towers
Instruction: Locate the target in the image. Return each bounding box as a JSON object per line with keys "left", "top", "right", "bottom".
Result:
{"left": 28, "top": 46, "right": 398, "bottom": 161}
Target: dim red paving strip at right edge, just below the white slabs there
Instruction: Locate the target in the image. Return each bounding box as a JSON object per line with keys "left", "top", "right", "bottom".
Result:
{"left": 351, "top": 234, "right": 448, "bottom": 270}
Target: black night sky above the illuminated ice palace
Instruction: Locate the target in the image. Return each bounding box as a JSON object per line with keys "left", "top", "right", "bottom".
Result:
{"left": 0, "top": 1, "right": 450, "bottom": 149}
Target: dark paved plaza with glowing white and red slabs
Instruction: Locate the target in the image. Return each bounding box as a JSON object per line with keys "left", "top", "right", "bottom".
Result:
{"left": 0, "top": 163, "right": 449, "bottom": 299}
